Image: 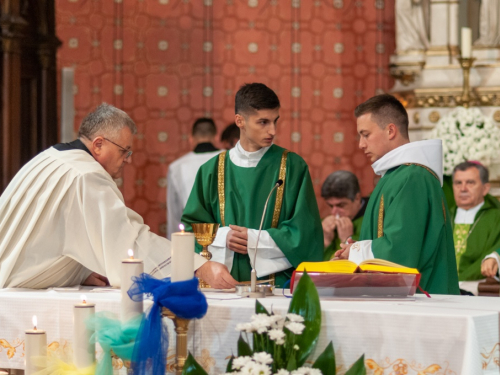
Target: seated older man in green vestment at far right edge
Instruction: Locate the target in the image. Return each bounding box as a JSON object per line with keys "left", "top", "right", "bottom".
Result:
{"left": 450, "top": 161, "right": 500, "bottom": 282}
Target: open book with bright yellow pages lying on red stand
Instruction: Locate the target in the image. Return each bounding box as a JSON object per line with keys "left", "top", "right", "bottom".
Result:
{"left": 297, "top": 259, "right": 419, "bottom": 275}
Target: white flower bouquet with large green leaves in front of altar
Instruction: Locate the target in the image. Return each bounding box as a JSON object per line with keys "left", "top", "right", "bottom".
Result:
{"left": 183, "top": 273, "right": 366, "bottom": 375}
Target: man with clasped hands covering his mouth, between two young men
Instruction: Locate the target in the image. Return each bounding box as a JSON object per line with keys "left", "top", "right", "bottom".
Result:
{"left": 321, "top": 171, "right": 368, "bottom": 260}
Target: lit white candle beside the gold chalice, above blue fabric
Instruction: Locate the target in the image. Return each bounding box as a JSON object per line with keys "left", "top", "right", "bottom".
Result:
{"left": 170, "top": 224, "right": 195, "bottom": 282}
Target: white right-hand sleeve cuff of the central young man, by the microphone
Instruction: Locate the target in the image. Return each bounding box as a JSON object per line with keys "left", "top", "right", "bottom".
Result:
{"left": 247, "top": 229, "right": 292, "bottom": 277}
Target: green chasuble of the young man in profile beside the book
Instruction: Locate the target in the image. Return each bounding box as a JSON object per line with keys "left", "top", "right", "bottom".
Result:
{"left": 360, "top": 164, "right": 459, "bottom": 294}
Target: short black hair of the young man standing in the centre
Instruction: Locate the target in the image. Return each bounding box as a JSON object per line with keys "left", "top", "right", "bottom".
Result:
{"left": 234, "top": 83, "right": 280, "bottom": 115}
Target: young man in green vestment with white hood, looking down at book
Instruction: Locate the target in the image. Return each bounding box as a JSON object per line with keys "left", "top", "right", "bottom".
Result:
{"left": 336, "top": 94, "right": 459, "bottom": 294}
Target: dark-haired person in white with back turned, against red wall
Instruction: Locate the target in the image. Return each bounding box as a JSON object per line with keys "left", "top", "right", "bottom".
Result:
{"left": 167, "top": 117, "right": 220, "bottom": 240}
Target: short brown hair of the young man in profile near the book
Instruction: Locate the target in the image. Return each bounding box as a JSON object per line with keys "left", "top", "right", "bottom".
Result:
{"left": 354, "top": 94, "right": 408, "bottom": 139}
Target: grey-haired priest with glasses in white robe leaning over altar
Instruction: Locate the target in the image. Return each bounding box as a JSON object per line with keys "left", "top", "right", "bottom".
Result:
{"left": 0, "top": 104, "right": 236, "bottom": 289}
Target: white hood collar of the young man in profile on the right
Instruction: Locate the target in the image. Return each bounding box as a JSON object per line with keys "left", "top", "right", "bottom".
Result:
{"left": 372, "top": 139, "right": 443, "bottom": 186}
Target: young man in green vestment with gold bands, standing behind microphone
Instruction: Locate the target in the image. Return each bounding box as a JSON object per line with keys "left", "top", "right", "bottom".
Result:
{"left": 182, "top": 83, "right": 323, "bottom": 286}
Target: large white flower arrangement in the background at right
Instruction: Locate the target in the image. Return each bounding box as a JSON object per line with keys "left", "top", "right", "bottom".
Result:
{"left": 430, "top": 107, "right": 500, "bottom": 175}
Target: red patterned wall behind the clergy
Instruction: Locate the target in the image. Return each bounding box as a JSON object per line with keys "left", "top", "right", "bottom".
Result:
{"left": 56, "top": 0, "right": 395, "bottom": 233}
